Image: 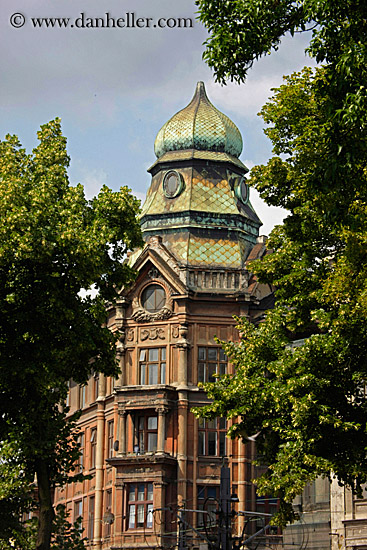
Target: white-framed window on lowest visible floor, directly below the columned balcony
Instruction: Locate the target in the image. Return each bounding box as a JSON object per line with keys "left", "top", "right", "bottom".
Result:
{"left": 126, "top": 481, "right": 154, "bottom": 531}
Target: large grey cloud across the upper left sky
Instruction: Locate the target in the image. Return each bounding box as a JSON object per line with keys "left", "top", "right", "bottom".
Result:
{"left": 0, "top": 0, "right": 208, "bottom": 125}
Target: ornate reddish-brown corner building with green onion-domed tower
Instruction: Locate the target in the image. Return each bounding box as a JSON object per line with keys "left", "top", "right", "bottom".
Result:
{"left": 55, "top": 82, "right": 276, "bottom": 550}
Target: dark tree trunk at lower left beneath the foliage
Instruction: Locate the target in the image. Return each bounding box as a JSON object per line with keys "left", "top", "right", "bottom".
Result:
{"left": 36, "top": 460, "right": 55, "bottom": 550}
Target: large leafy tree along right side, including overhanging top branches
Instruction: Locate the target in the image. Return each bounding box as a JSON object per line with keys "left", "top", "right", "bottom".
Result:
{"left": 197, "top": 0, "right": 367, "bottom": 524}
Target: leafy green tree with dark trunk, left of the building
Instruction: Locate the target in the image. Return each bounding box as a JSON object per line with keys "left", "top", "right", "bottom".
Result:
{"left": 0, "top": 119, "right": 142, "bottom": 550}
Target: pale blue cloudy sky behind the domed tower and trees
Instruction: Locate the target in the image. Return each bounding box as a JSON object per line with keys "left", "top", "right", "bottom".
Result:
{"left": 0, "top": 0, "right": 311, "bottom": 235}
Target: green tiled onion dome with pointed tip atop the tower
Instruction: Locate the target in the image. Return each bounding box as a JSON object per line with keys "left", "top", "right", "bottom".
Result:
{"left": 154, "top": 82, "right": 242, "bottom": 158}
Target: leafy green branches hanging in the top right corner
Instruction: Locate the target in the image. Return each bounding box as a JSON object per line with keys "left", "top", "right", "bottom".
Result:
{"left": 196, "top": 0, "right": 367, "bottom": 84}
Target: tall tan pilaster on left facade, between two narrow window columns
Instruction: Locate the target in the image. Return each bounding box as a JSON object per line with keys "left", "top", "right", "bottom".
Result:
{"left": 94, "top": 374, "right": 106, "bottom": 550}
